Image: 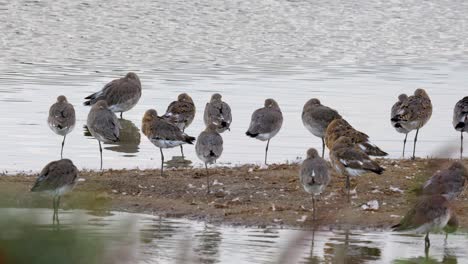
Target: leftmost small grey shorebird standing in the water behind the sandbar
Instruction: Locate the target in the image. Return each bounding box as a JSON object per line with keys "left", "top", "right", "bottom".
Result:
{"left": 47, "top": 95, "right": 76, "bottom": 159}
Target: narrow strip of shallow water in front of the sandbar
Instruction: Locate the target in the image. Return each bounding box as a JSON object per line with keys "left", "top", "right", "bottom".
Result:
{"left": 1, "top": 209, "right": 468, "bottom": 263}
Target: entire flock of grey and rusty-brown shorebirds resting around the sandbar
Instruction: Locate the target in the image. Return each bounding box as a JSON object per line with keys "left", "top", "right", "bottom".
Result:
{"left": 32, "top": 72, "right": 468, "bottom": 250}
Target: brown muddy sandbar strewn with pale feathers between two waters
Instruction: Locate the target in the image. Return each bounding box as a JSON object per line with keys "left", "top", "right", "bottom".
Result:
{"left": 0, "top": 159, "right": 468, "bottom": 229}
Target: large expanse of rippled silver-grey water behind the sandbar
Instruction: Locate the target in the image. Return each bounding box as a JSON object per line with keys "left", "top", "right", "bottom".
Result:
{"left": 0, "top": 0, "right": 468, "bottom": 172}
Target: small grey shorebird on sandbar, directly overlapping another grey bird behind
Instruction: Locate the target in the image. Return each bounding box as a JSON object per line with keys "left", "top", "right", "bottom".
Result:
{"left": 195, "top": 123, "right": 223, "bottom": 193}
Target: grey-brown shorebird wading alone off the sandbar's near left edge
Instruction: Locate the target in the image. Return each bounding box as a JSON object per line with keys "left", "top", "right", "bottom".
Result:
{"left": 31, "top": 159, "right": 78, "bottom": 224}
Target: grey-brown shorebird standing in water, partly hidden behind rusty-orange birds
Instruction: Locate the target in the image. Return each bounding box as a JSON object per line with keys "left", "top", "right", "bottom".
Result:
{"left": 302, "top": 98, "right": 342, "bottom": 158}
